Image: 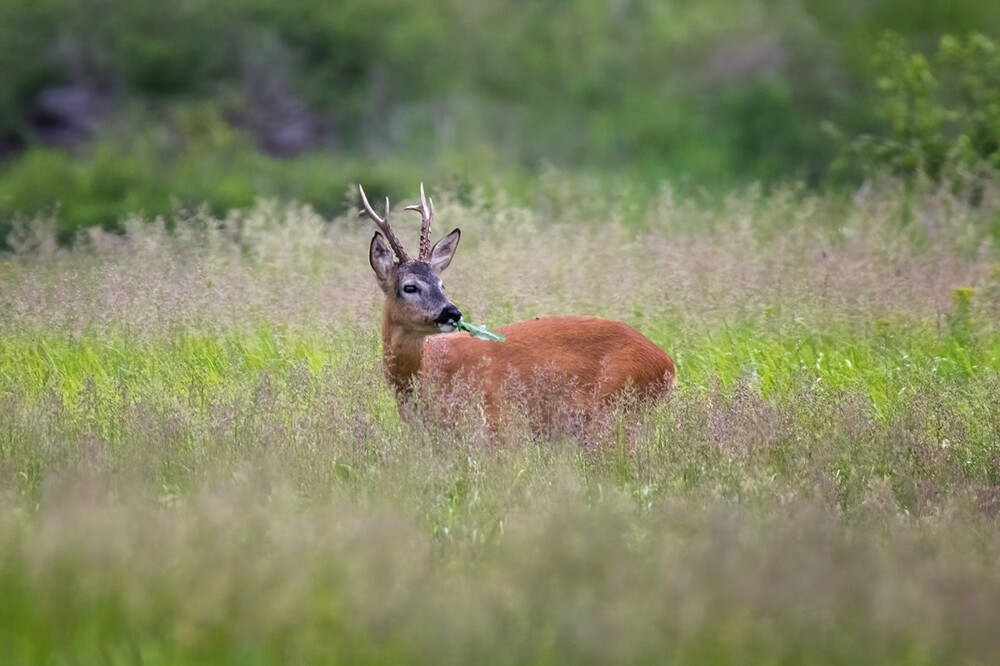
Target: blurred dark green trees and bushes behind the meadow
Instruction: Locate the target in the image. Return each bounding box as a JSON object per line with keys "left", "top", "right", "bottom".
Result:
{"left": 0, "top": 0, "right": 1000, "bottom": 239}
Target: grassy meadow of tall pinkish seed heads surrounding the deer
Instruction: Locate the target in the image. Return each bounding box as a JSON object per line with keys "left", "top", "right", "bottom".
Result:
{"left": 0, "top": 178, "right": 1000, "bottom": 664}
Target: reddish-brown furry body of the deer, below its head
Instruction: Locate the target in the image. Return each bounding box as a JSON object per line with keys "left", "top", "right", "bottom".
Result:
{"left": 383, "top": 316, "right": 676, "bottom": 428}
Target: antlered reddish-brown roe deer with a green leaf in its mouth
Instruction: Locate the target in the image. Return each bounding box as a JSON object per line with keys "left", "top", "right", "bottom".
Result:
{"left": 358, "top": 183, "right": 677, "bottom": 431}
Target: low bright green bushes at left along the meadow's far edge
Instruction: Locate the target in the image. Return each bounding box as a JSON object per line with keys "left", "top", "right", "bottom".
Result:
{"left": 0, "top": 104, "right": 433, "bottom": 247}
